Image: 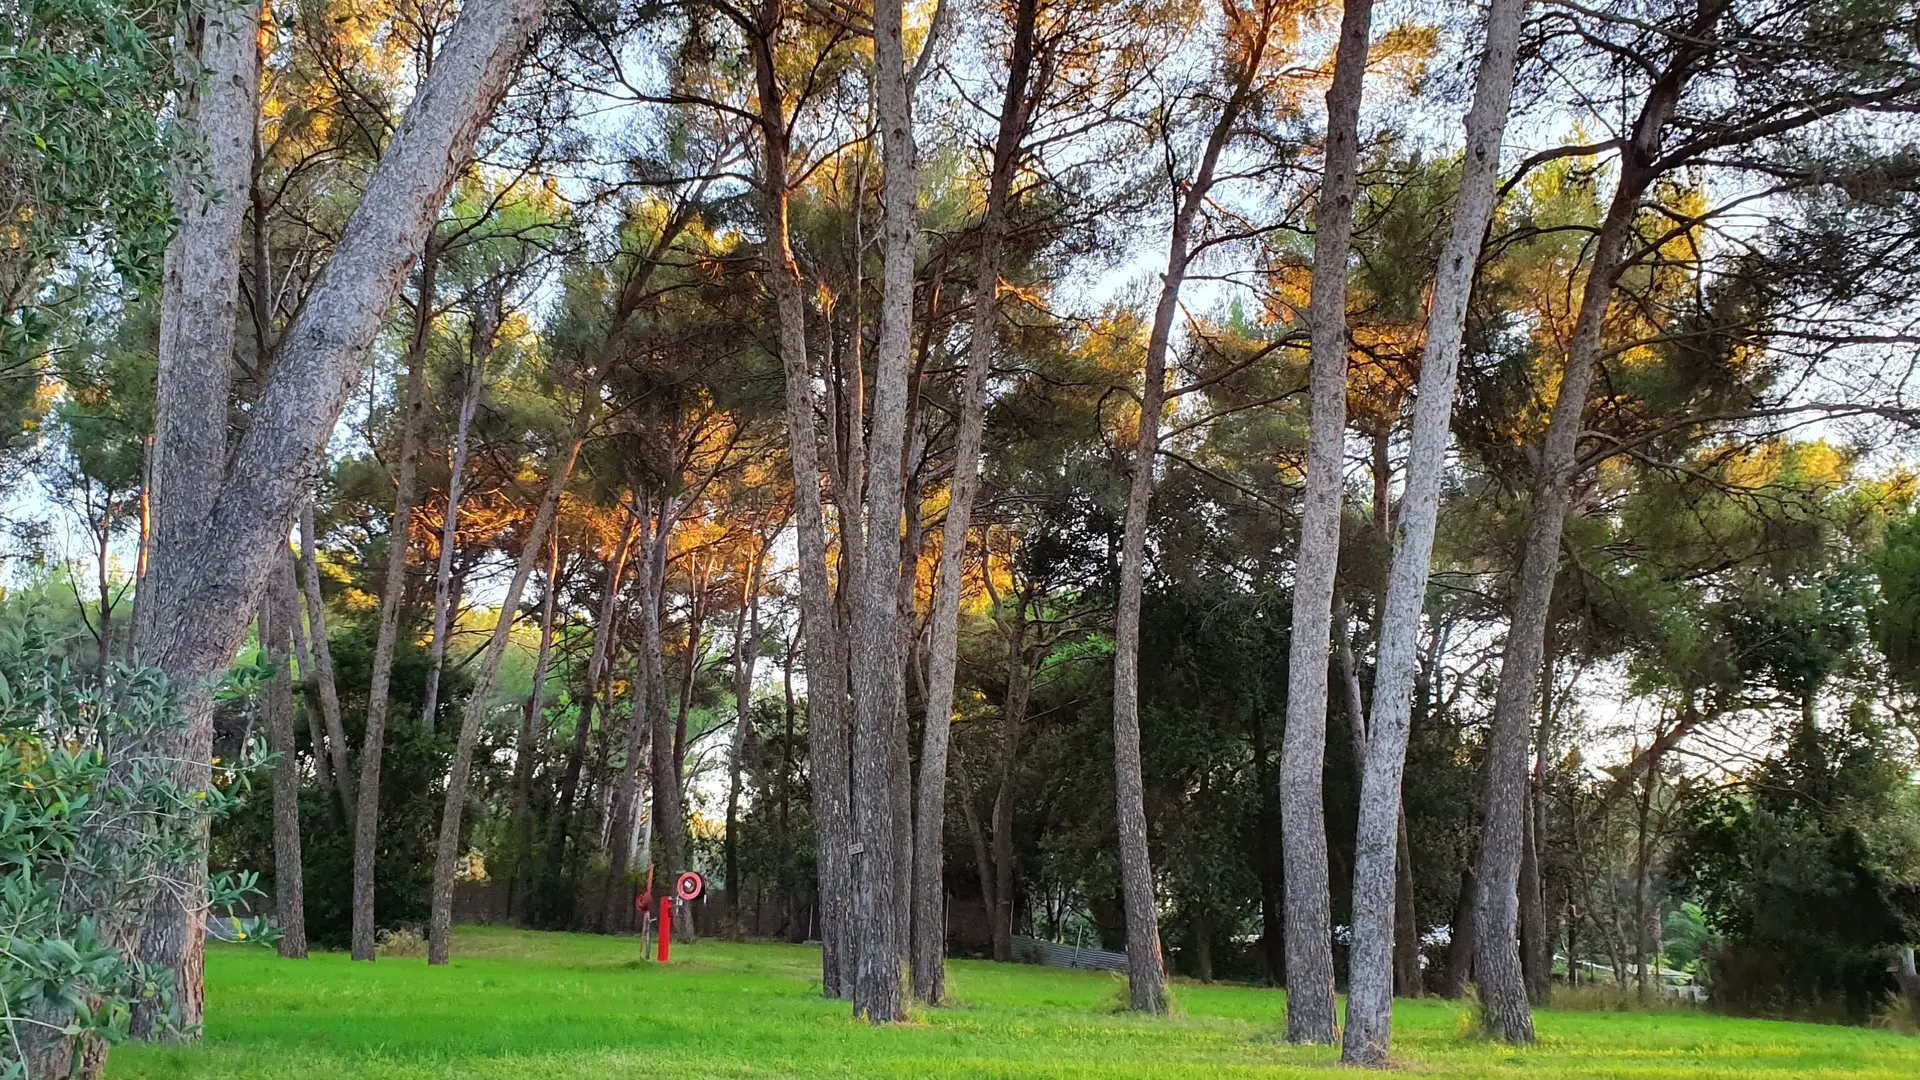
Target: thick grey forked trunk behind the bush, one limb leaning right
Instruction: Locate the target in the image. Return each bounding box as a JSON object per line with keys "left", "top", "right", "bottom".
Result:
{"left": 134, "top": 0, "right": 545, "bottom": 1030}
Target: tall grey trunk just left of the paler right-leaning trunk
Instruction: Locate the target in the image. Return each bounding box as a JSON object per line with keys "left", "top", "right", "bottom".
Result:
{"left": 1281, "top": 0, "right": 1392, "bottom": 1043}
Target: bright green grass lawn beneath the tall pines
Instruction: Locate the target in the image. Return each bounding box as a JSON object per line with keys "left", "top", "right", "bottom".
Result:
{"left": 109, "top": 914, "right": 1920, "bottom": 1080}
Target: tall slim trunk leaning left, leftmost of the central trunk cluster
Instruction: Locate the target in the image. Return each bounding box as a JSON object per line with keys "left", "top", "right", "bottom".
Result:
{"left": 752, "top": 0, "right": 852, "bottom": 997}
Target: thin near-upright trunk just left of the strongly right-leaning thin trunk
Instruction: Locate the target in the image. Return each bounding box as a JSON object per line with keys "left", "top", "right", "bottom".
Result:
{"left": 353, "top": 240, "right": 440, "bottom": 961}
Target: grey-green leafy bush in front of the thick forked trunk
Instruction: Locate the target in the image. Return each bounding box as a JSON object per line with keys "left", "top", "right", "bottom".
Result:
{"left": 0, "top": 601, "right": 271, "bottom": 1080}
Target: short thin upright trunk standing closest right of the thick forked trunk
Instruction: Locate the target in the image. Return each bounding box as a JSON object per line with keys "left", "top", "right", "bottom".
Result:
{"left": 259, "top": 561, "right": 307, "bottom": 959}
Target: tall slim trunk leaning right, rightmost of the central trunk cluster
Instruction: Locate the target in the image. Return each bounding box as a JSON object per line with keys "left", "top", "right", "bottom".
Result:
{"left": 910, "top": 0, "right": 1039, "bottom": 1005}
